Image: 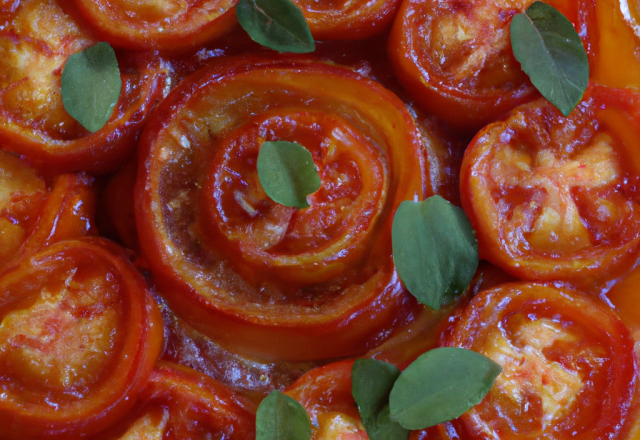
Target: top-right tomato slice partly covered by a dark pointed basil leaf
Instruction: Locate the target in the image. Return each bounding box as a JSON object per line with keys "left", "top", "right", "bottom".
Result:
{"left": 388, "top": 0, "right": 578, "bottom": 129}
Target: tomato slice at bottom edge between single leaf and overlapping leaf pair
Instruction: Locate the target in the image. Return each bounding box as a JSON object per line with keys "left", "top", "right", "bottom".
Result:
{"left": 285, "top": 360, "right": 368, "bottom": 440}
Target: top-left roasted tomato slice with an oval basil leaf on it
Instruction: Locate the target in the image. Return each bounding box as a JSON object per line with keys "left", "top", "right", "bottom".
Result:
{"left": 0, "top": 0, "right": 165, "bottom": 174}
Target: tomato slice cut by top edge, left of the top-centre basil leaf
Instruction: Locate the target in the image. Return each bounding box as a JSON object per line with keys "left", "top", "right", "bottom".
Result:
{"left": 75, "top": 0, "right": 237, "bottom": 51}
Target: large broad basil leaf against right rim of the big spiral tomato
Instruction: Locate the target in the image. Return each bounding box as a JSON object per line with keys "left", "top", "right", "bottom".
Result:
{"left": 391, "top": 196, "right": 479, "bottom": 309}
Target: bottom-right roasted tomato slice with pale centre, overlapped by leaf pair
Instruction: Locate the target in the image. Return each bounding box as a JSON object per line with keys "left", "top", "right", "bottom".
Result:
{"left": 446, "top": 282, "right": 637, "bottom": 440}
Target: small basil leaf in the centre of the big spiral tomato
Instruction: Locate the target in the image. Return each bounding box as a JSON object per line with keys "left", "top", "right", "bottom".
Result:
{"left": 257, "top": 141, "right": 321, "bottom": 209}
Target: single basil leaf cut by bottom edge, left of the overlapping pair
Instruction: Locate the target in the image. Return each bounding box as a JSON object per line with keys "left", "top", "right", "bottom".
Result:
{"left": 256, "top": 391, "right": 311, "bottom": 440}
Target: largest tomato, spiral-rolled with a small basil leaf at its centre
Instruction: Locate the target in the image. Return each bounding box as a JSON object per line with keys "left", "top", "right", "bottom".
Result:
{"left": 136, "top": 57, "right": 430, "bottom": 361}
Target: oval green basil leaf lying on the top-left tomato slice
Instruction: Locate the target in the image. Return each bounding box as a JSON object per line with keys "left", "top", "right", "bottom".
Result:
{"left": 60, "top": 43, "right": 122, "bottom": 133}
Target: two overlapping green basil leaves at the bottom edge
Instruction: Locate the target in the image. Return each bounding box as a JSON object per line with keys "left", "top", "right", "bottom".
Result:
{"left": 351, "top": 347, "right": 502, "bottom": 434}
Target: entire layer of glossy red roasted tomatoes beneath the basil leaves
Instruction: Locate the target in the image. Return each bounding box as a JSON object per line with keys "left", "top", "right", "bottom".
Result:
{"left": 0, "top": 0, "right": 640, "bottom": 440}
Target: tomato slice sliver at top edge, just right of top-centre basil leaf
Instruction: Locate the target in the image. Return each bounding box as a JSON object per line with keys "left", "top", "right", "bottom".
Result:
{"left": 293, "top": 0, "right": 401, "bottom": 40}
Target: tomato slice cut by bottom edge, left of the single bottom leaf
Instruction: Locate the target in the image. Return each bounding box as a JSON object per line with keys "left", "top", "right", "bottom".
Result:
{"left": 95, "top": 362, "right": 256, "bottom": 440}
